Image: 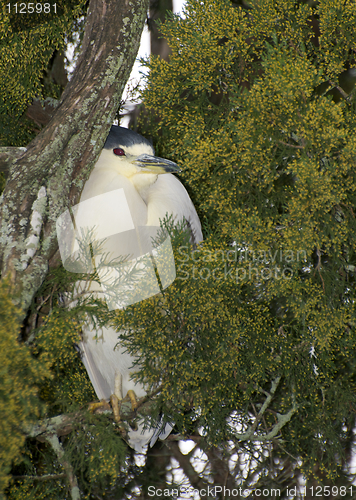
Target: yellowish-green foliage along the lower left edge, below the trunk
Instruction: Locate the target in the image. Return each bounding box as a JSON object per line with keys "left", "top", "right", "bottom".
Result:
{"left": 0, "top": 281, "right": 49, "bottom": 494}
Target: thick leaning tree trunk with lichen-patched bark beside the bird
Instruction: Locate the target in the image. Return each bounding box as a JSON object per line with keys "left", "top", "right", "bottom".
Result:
{"left": 0, "top": 0, "right": 148, "bottom": 315}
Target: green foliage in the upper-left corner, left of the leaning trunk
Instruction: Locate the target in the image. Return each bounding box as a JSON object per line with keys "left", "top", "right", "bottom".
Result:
{"left": 0, "top": 0, "right": 85, "bottom": 146}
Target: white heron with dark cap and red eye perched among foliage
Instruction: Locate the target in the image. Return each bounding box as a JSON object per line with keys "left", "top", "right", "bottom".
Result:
{"left": 71, "top": 126, "right": 203, "bottom": 452}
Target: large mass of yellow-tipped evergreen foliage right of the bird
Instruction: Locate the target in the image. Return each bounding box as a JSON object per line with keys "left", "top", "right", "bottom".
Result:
{"left": 137, "top": 0, "right": 356, "bottom": 477}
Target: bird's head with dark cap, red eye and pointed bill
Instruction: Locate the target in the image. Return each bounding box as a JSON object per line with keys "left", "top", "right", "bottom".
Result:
{"left": 103, "top": 125, "right": 180, "bottom": 198}
